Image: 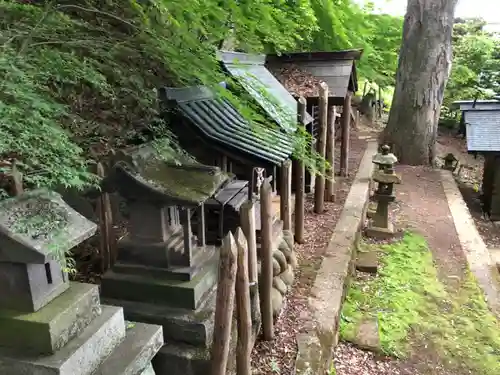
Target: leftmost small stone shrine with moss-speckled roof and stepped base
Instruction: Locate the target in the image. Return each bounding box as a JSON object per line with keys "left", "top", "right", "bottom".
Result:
{"left": 0, "top": 190, "right": 163, "bottom": 375}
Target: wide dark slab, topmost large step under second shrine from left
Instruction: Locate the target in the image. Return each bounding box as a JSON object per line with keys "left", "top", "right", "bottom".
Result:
{"left": 101, "top": 261, "right": 217, "bottom": 310}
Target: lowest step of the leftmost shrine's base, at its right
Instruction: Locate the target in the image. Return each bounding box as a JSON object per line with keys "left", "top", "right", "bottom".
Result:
{"left": 92, "top": 322, "right": 163, "bottom": 375}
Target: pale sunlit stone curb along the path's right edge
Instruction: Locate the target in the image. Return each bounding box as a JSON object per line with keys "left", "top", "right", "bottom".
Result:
{"left": 441, "top": 171, "right": 500, "bottom": 316}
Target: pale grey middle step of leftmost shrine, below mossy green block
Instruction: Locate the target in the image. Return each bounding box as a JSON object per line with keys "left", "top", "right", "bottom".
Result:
{"left": 0, "top": 306, "right": 125, "bottom": 375}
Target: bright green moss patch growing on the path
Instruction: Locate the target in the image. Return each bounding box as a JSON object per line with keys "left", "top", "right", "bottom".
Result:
{"left": 340, "top": 233, "right": 500, "bottom": 375}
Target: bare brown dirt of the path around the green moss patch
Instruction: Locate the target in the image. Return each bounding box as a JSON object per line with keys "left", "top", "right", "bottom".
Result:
{"left": 335, "top": 166, "right": 500, "bottom": 375}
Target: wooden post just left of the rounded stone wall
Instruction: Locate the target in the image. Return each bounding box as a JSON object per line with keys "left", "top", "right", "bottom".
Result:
{"left": 259, "top": 178, "right": 274, "bottom": 341}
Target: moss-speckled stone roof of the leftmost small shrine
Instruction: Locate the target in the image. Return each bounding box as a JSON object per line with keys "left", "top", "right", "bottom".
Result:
{"left": 0, "top": 189, "right": 97, "bottom": 264}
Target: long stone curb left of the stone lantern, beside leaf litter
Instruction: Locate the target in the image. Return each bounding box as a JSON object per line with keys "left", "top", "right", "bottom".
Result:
{"left": 295, "top": 141, "right": 377, "bottom": 375}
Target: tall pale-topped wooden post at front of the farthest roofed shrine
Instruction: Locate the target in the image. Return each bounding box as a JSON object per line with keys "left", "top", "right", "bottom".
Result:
{"left": 314, "top": 82, "right": 328, "bottom": 214}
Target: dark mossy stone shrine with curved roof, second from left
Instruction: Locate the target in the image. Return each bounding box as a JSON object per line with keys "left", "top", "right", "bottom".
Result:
{"left": 101, "top": 155, "right": 240, "bottom": 375}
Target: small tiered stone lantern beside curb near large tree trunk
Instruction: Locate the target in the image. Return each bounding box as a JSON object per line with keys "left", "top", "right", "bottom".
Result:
{"left": 366, "top": 145, "right": 401, "bottom": 239}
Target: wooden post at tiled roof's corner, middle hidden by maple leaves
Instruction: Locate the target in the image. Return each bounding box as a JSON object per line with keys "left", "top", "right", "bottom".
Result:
{"left": 294, "top": 96, "right": 307, "bottom": 244}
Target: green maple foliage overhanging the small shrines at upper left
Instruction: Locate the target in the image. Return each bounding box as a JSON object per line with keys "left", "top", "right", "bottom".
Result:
{"left": 0, "top": 0, "right": 316, "bottom": 194}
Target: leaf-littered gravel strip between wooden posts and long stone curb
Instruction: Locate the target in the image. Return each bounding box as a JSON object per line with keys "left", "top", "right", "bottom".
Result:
{"left": 252, "top": 134, "right": 366, "bottom": 375}
